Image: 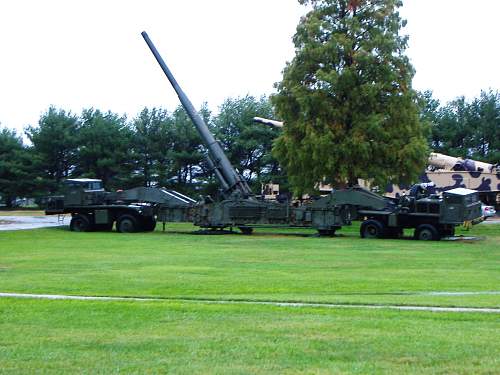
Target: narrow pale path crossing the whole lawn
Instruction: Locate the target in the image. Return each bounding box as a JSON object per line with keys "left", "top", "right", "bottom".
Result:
{"left": 0, "top": 293, "right": 500, "bottom": 314}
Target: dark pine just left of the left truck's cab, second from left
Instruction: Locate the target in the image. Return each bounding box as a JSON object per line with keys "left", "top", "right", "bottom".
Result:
{"left": 25, "top": 107, "right": 79, "bottom": 192}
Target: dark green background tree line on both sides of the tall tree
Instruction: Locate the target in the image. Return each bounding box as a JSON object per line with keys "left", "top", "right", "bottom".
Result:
{"left": 0, "top": 90, "right": 500, "bottom": 206}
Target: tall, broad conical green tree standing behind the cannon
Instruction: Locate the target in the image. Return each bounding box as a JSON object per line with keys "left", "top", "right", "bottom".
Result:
{"left": 272, "top": 0, "right": 428, "bottom": 191}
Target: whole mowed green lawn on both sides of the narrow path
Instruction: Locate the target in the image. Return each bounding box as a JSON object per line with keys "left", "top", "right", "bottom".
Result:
{"left": 0, "top": 224, "right": 500, "bottom": 374}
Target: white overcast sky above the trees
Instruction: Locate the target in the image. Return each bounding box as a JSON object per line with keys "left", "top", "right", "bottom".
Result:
{"left": 0, "top": 0, "right": 500, "bottom": 134}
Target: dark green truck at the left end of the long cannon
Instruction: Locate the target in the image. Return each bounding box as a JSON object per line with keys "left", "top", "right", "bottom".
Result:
{"left": 45, "top": 178, "right": 195, "bottom": 233}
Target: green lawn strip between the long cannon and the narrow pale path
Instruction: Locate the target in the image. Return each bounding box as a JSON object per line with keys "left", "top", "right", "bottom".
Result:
{"left": 0, "top": 224, "right": 500, "bottom": 307}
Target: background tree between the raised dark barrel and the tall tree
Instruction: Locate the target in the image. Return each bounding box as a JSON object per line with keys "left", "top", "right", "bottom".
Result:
{"left": 214, "top": 96, "right": 280, "bottom": 187}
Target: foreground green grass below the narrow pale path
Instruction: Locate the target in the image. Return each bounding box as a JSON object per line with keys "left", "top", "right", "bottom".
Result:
{"left": 0, "top": 299, "right": 500, "bottom": 374}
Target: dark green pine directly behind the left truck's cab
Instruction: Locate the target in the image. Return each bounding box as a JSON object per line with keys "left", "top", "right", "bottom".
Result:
{"left": 75, "top": 109, "right": 133, "bottom": 189}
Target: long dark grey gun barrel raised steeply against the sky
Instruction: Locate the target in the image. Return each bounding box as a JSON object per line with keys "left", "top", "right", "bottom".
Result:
{"left": 141, "top": 31, "right": 252, "bottom": 200}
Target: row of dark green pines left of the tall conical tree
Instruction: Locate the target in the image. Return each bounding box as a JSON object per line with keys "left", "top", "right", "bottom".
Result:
{"left": 0, "top": 96, "right": 283, "bottom": 206}
